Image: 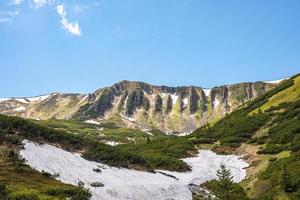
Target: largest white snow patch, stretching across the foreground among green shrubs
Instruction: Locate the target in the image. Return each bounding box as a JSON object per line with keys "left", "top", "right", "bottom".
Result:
{"left": 20, "top": 141, "right": 248, "bottom": 200}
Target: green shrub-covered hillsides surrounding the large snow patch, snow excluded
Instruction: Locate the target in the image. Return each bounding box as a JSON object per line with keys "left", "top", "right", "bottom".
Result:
{"left": 0, "top": 75, "right": 300, "bottom": 200}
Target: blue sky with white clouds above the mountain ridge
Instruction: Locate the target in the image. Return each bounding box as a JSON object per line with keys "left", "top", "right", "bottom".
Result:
{"left": 0, "top": 0, "right": 300, "bottom": 97}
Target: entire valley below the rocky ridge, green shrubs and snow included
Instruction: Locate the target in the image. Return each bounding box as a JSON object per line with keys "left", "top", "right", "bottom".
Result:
{"left": 0, "top": 75, "right": 300, "bottom": 200}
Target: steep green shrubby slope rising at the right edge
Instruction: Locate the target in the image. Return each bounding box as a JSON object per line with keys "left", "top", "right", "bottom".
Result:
{"left": 190, "top": 75, "right": 300, "bottom": 200}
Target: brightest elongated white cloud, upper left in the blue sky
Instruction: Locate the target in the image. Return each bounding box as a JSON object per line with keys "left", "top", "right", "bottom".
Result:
{"left": 56, "top": 4, "right": 81, "bottom": 36}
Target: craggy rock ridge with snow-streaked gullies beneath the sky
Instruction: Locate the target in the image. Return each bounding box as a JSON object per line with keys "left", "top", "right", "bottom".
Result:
{"left": 0, "top": 81, "right": 276, "bottom": 133}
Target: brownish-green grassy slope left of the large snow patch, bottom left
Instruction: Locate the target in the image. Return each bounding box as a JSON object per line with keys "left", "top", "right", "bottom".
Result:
{"left": 0, "top": 133, "right": 87, "bottom": 200}
